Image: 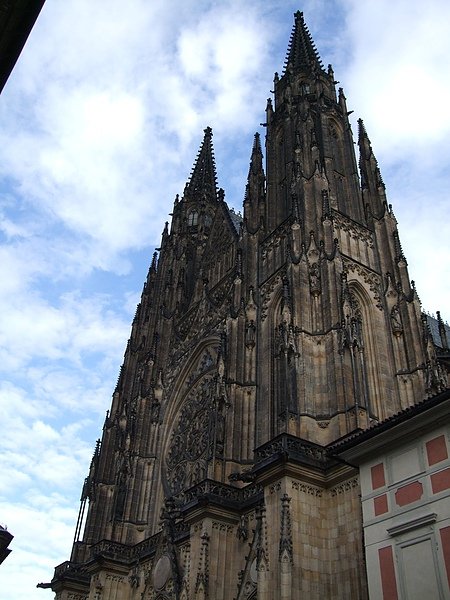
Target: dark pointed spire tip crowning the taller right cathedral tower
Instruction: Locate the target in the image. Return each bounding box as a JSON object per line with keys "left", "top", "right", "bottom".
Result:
{"left": 284, "top": 11, "right": 323, "bottom": 73}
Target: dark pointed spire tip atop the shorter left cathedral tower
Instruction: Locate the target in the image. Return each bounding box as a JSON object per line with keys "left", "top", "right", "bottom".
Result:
{"left": 184, "top": 127, "right": 217, "bottom": 202}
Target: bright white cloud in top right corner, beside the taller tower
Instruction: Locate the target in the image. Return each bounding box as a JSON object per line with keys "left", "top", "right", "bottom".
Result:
{"left": 349, "top": 0, "right": 450, "bottom": 150}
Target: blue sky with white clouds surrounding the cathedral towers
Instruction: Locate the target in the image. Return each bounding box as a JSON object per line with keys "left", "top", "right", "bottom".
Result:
{"left": 0, "top": 0, "right": 450, "bottom": 600}
